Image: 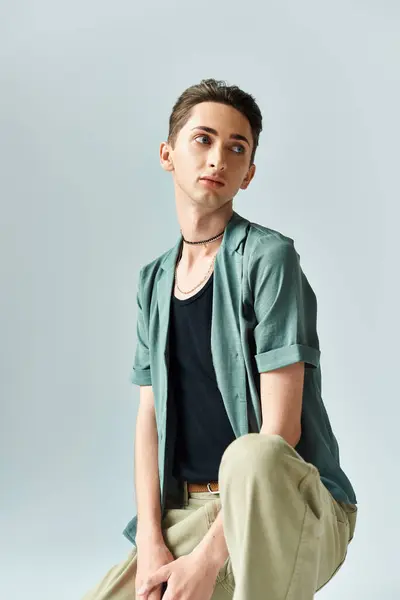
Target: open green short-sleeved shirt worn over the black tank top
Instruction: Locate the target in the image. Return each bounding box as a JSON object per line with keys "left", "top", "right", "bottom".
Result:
{"left": 123, "top": 211, "right": 357, "bottom": 543}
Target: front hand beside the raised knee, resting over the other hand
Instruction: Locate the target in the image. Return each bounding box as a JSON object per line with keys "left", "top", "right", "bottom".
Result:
{"left": 136, "top": 548, "right": 219, "bottom": 600}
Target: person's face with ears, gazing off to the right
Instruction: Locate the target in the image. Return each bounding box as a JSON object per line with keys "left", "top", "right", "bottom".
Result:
{"left": 160, "top": 102, "right": 255, "bottom": 208}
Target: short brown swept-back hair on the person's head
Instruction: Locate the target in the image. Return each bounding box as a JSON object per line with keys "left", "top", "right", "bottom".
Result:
{"left": 168, "top": 79, "right": 262, "bottom": 165}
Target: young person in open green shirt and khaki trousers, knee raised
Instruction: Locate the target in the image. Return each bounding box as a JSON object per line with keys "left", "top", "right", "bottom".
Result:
{"left": 85, "top": 79, "right": 357, "bottom": 600}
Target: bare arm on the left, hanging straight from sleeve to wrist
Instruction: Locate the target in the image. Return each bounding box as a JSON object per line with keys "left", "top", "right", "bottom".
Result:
{"left": 135, "top": 386, "right": 162, "bottom": 542}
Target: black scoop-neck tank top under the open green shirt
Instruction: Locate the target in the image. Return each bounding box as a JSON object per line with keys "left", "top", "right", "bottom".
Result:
{"left": 169, "top": 274, "right": 235, "bottom": 483}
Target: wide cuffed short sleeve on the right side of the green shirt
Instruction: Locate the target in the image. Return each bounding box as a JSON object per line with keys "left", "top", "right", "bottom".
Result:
{"left": 251, "top": 239, "right": 320, "bottom": 373}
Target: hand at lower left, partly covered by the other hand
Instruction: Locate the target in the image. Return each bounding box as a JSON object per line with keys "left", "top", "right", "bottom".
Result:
{"left": 135, "top": 539, "right": 175, "bottom": 600}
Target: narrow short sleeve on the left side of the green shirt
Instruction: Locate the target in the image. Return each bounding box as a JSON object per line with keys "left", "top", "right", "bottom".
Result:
{"left": 130, "top": 269, "right": 151, "bottom": 385}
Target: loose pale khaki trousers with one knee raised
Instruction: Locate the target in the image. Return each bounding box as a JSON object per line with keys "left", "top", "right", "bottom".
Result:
{"left": 83, "top": 433, "right": 357, "bottom": 600}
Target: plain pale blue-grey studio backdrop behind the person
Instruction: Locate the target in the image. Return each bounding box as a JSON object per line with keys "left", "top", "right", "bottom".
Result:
{"left": 0, "top": 0, "right": 400, "bottom": 600}
